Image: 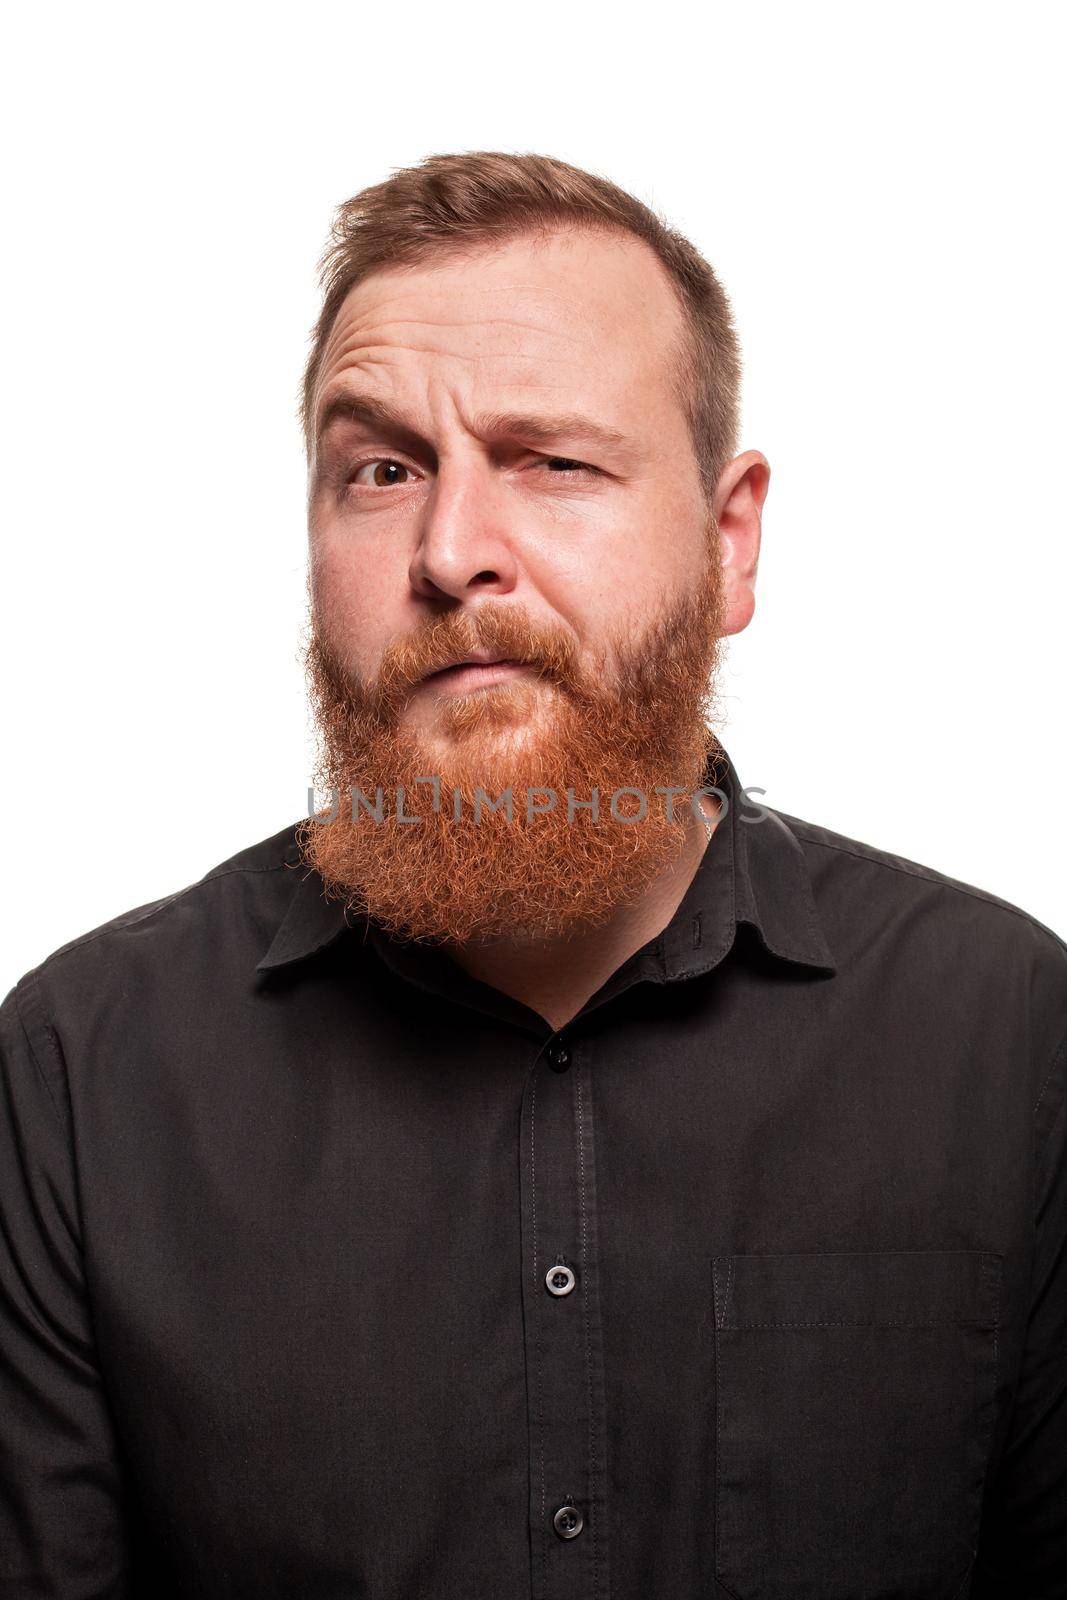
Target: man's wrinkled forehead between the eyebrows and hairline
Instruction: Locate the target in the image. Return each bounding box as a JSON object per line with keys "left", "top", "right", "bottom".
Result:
{"left": 315, "top": 229, "right": 685, "bottom": 435}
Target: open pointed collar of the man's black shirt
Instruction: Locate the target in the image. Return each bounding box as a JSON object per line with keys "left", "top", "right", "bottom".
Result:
{"left": 256, "top": 752, "right": 837, "bottom": 1000}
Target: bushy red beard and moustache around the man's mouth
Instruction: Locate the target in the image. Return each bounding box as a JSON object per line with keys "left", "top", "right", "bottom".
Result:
{"left": 298, "top": 538, "right": 723, "bottom": 942}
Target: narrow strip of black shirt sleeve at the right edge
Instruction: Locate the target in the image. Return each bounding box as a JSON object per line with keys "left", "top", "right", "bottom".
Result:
{"left": 973, "top": 1040, "right": 1067, "bottom": 1600}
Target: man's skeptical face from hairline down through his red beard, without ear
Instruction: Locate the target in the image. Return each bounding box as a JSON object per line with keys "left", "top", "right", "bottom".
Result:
{"left": 309, "top": 230, "right": 742, "bottom": 938}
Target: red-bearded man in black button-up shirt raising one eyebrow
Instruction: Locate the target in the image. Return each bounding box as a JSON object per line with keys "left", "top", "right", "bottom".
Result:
{"left": 0, "top": 152, "right": 1067, "bottom": 1600}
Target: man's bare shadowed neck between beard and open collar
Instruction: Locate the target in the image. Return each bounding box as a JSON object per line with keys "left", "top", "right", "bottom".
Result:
{"left": 445, "top": 795, "right": 718, "bottom": 1030}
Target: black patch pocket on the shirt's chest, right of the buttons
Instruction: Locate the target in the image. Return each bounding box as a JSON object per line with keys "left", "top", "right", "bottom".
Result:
{"left": 712, "top": 1250, "right": 1001, "bottom": 1600}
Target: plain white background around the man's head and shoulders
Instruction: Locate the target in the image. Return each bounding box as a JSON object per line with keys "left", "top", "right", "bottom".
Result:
{"left": 0, "top": 0, "right": 1067, "bottom": 990}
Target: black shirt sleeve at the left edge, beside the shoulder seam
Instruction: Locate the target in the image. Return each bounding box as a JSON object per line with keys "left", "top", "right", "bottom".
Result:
{"left": 0, "top": 973, "right": 130, "bottom": 1600}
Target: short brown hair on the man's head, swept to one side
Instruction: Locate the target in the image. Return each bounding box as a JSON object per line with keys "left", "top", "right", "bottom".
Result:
{"left": 299, "top": 150, "right": 741, "bottom": 504}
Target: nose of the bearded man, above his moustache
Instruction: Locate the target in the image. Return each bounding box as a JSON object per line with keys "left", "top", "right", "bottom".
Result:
{"left": 410, "top": 458, "right": 518, "bottom": 600}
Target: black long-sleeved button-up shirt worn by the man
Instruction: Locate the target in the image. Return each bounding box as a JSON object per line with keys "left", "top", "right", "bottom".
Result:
{"left": 0, "top": 752, "right": 1067, "bottom": 1600}
